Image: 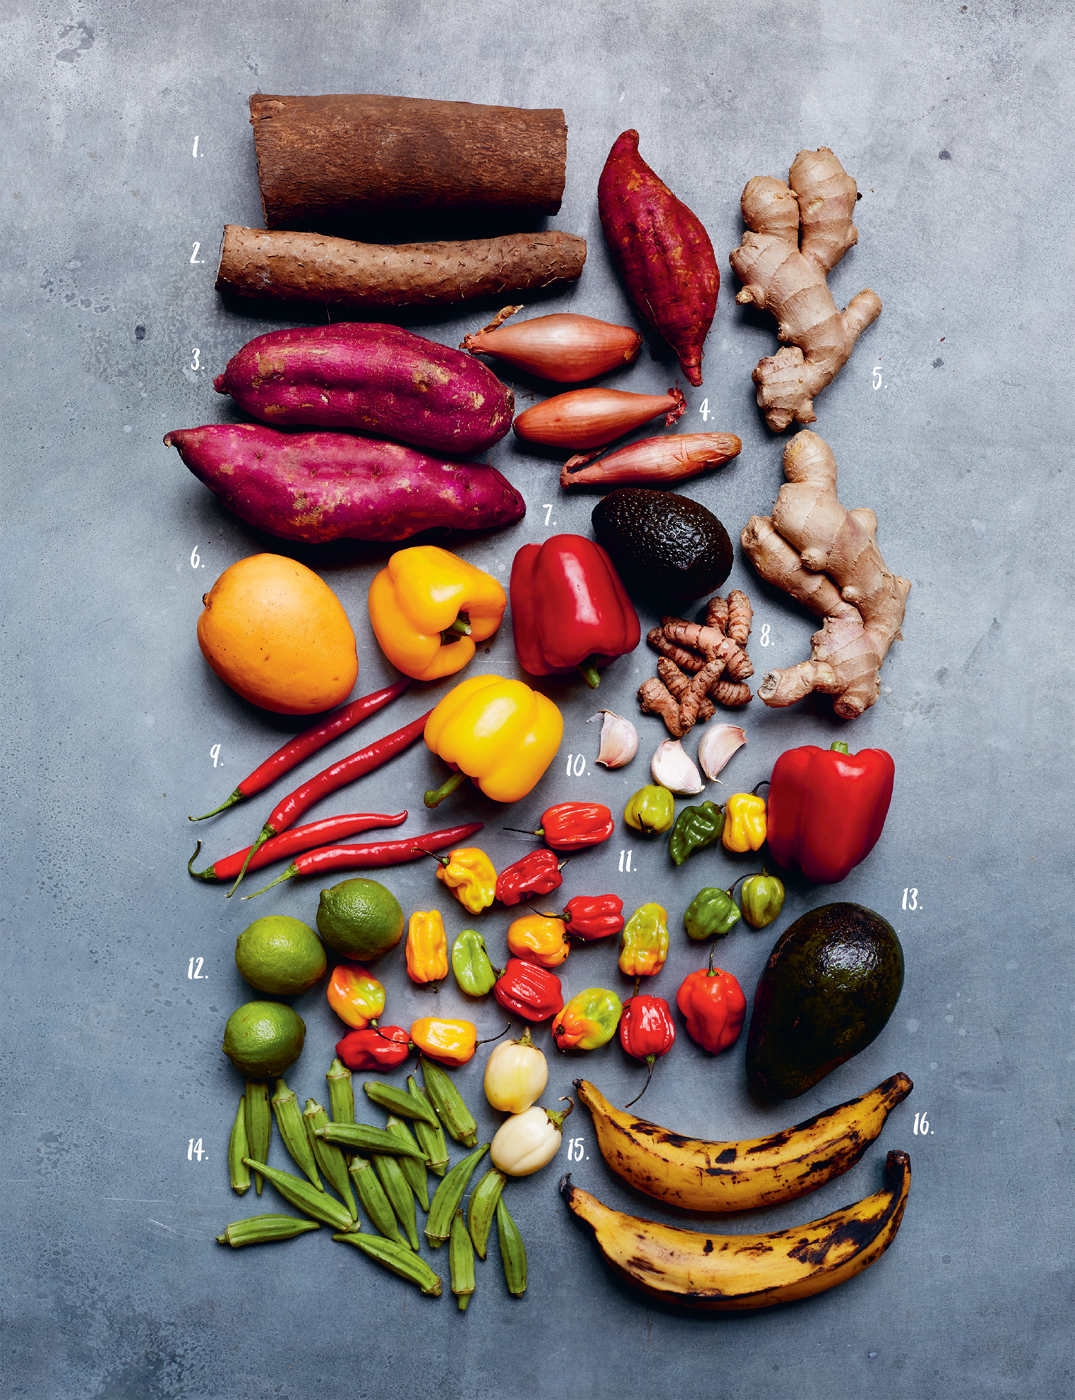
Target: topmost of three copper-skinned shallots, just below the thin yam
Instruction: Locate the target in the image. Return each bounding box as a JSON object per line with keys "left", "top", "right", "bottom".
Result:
{"left": 459, "top": 307, "right": 642, "bottom": 384}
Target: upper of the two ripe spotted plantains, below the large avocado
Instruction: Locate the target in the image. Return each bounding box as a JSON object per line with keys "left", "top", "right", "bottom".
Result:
{"left": 575, "top": 1074, "right": 913, "bottom": 1214}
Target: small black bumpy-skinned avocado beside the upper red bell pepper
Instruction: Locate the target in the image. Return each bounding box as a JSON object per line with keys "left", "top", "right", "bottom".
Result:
{"left": 591, "top": 486, "right": 732, "bottom": 606}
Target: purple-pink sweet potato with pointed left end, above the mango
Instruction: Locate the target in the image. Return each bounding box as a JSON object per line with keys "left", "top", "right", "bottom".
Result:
{"left": 164, "top": 423, "right": 526, "bottom": 545}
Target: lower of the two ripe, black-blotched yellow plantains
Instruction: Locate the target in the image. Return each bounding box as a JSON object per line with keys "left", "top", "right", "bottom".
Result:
{"left": 560, "top": 1152, "right": 911, "bottom": 1309}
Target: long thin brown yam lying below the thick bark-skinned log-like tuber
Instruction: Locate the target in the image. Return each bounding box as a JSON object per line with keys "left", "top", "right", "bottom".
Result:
{"left": 217, "top": 224, "right": 586, "bottom": 309}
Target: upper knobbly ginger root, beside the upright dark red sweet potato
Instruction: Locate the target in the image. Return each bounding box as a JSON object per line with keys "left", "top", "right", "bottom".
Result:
{"left": 731, "top": 147, "right": 880, "bottom": 433}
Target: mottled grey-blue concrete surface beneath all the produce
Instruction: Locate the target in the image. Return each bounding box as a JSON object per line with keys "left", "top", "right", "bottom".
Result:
{"left": 0, "top": 0, "right": 1075, "bottom": 1400}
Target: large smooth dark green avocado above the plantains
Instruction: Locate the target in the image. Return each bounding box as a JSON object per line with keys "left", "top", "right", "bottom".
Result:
{"left": 746, "top": 904, "right": 903, "bottom": 1099}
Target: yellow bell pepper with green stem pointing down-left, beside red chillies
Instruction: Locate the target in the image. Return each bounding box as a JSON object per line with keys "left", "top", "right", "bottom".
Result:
{"left": 426, "top": 675, "right": 564, "bottom": 806}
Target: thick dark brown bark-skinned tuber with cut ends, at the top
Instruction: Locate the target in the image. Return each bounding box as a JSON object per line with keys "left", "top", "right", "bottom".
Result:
{"left": 251, "top": 92, "right": 567, "bottom": 228}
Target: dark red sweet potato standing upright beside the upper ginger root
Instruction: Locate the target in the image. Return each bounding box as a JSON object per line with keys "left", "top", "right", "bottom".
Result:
{"left": 598, "top": 132, "right": 721, "bottom": 388}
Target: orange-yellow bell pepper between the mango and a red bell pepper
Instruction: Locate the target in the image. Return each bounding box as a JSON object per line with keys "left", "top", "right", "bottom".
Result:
{"left": 370, "top": 545, "right": 508, "bottom": 680}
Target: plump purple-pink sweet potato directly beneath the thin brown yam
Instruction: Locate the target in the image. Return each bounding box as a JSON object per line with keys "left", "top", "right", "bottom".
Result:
{"left": 213, "top": 322, "right": 515, "bottom": 456}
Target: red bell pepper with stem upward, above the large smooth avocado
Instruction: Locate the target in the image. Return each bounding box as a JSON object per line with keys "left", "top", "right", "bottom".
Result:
{"left": 767, "top": 743, "right": 896, "bottom": 885}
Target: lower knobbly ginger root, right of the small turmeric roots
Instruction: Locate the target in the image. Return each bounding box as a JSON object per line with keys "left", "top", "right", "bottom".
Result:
{"left": 740, "top": 433, "right": 911, "bottom": 720}
